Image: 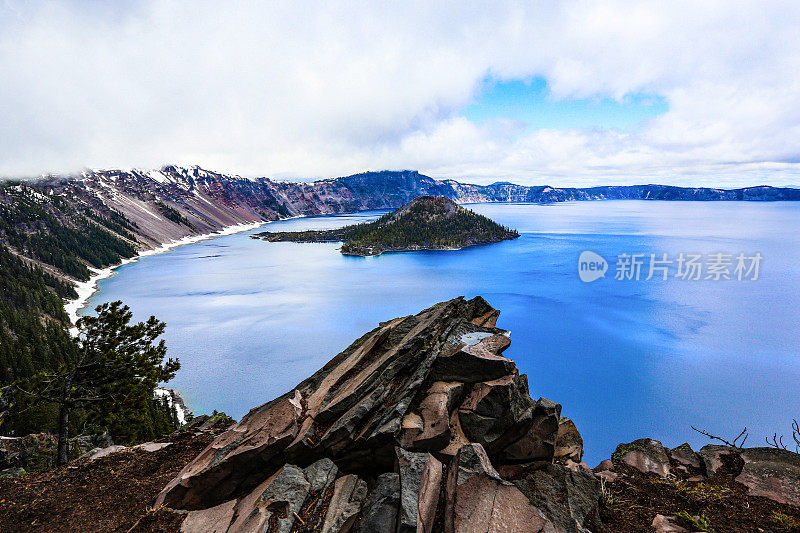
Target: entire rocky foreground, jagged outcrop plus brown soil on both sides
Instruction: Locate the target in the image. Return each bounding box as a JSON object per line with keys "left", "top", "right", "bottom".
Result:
{"left": 0, "top": 298, "right": 800, "bottom": 533}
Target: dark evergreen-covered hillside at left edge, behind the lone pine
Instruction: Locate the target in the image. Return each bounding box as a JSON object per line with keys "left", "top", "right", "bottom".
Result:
{"left": 0, "top": 182, "right": 177, "bottom": 443}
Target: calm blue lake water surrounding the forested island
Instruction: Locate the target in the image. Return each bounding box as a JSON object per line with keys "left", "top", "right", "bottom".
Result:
{"left": 81, "top": 201, "right": 800, "bottom": 466}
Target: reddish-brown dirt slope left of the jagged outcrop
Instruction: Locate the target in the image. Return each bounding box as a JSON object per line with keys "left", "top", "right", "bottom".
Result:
{"left": 0, "top": 428, "right": 222, "bottom": 533}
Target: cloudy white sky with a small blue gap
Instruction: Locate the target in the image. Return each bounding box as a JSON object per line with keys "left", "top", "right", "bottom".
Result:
{"left": 0, "top": 0, "right": 800, "bottom": 186}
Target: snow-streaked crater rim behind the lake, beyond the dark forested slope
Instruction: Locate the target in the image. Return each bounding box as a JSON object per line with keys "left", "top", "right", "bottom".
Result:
{"left": 12, "top": 165, "right": 800, "bottom": 244}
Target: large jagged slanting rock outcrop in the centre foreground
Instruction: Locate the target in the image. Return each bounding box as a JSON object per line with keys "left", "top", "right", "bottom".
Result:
{"left": 156, "top": 297, "right": 600, "bottom": 533}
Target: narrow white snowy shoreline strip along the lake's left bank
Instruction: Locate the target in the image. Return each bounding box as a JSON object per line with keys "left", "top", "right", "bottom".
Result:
{"left": 64, "top": 220, "right": 262, "bottom": 328}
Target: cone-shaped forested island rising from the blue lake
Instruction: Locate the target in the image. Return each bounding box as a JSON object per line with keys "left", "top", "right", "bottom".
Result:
{"left": 253, "top": 196, "right": 519, "bottom": 256}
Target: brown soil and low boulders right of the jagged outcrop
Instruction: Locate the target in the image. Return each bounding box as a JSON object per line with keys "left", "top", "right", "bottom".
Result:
{"left": 594, "top": 439, "right": 800, "bottom": 533}
